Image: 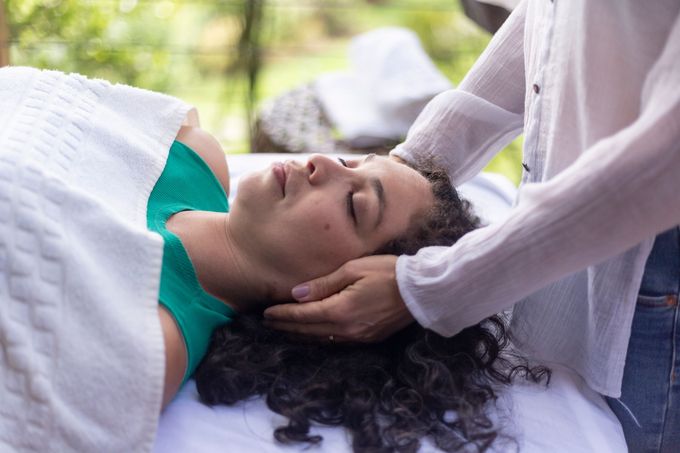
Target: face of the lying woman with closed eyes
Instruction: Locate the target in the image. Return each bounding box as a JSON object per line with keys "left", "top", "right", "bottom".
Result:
{"left": 230, "top": 154, "right": 433, "bottom": 283}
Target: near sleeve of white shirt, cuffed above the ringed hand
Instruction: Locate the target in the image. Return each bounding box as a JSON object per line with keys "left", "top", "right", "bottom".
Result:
{"left": 397, "top": 13, "right": 680, "bottom": 336}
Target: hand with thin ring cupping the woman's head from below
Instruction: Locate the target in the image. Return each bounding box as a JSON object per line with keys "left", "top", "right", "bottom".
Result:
{"left": 264, "top": 255, "right": 413, "bottom": 343}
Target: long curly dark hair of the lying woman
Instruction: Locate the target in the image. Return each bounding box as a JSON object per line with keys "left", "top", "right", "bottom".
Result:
{"left": 194, "top": 161, "right": 550, "bottom": 452}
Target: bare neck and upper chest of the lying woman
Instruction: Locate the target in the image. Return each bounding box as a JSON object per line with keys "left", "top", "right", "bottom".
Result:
{"left": 168, "top": 211, "right": 290, "bottom": 312}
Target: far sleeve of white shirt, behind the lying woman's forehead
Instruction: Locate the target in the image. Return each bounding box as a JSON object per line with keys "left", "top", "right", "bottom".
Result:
{"left": 391, "top": 1, "right": 526, "bottom": 185}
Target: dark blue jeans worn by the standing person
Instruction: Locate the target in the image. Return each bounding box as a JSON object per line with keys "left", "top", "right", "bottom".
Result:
{"left": 607, "top": 227, "right": 680, "bottom": 453}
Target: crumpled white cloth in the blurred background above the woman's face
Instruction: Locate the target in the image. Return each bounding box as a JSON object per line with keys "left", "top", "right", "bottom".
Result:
{"left": 314, "top": 27, "right": 451, "bottom": 141}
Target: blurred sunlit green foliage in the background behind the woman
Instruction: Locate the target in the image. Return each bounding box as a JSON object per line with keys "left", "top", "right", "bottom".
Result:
{"left": 5, "top": 0, "right": 521, "bottom": 182}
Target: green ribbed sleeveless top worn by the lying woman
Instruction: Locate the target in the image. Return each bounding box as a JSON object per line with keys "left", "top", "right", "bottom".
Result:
{"left": 146, "top": 141, "right": 234, "bottom": 383}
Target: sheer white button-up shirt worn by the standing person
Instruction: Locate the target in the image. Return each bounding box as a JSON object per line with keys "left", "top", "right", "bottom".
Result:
{"left": 392, "top": 0, "right": 680, "bottom": 397}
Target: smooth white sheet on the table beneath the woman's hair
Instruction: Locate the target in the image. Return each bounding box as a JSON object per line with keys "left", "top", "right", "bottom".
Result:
{"left": 154, "top": 154, "right": 627, "bottom": 453}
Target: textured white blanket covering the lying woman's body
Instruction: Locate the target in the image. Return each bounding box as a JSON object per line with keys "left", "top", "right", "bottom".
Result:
{"left": 0, "top": 68, "right": 195, "bottom": 452}
